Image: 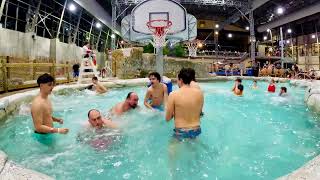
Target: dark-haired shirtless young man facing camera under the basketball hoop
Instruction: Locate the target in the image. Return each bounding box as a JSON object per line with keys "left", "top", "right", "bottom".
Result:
{"left": 144, "top": 72, "right": 168, "bottom": 111}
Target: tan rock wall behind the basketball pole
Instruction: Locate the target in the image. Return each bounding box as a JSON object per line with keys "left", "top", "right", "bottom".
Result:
{"left": 112, "top": 48, "right": 209, "bottom": 79}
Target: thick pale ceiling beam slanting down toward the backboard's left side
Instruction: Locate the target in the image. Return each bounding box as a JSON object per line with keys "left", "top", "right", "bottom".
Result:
{"left": 74, "top": 0, "right": 120, "bottom": 35}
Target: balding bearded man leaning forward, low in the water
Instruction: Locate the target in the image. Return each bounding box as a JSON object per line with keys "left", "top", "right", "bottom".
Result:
{"left": 111, "top": 92, "right": 139, "bottom": 115}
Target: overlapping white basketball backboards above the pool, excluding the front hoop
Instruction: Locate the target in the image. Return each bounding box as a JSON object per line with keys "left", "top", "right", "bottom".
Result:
{"left": 121, "top": 0, "right": 197, "bottom": 44}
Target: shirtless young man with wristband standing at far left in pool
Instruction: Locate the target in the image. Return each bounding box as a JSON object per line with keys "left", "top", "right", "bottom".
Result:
{"left": 31, "top": 74, "right": 69, "bottom": 134}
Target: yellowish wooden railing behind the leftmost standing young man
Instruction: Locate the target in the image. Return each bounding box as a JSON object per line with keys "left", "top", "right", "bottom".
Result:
{"left": 0, "top": 56, "right": 74, "bottom": 92}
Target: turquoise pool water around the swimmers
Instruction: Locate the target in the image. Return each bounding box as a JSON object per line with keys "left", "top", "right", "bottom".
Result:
{"left": 0, "top": 81, "right": 320, "bottom": 180}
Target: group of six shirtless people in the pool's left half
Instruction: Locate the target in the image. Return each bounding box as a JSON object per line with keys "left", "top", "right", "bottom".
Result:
{"left": 31, "top": 68, "right": 204, "bottom": 140}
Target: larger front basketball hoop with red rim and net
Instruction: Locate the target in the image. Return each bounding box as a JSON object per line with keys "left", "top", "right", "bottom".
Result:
{"left": 147, "top": 19, "right": 172, "bottom": 48}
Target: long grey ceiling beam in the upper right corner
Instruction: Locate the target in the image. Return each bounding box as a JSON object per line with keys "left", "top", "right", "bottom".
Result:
{"left": 257, "top": 2, "right": 320, "bottom": 32}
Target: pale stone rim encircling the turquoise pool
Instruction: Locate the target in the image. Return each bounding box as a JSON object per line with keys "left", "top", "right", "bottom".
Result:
{"left": 0, "top": 76, "right": 320, "bottom": 180}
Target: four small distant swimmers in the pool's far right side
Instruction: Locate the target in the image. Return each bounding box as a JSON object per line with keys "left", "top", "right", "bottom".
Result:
{"left": 232, "top": 79, "right": 288, "bottom": 97}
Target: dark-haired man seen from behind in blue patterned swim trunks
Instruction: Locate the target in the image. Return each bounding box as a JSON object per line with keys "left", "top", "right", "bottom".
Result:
{"left": 166, "top": 68, "right": 204, "bottom": 140}
